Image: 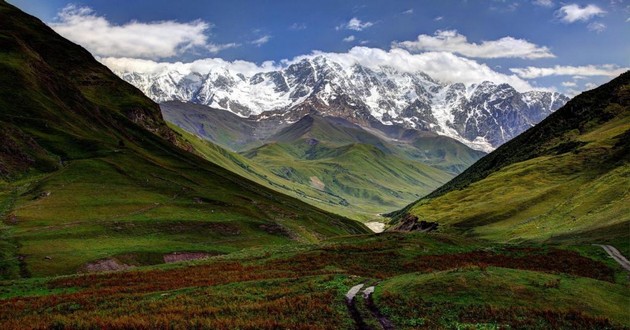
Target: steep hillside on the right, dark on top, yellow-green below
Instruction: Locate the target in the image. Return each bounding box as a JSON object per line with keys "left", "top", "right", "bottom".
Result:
{"left": 393, "top": 72, "right": 630, "bottom": 247}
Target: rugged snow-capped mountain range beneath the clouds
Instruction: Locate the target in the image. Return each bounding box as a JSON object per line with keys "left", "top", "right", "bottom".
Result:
{"left": 115, "top": 55, "right": 568, "bottom": 151}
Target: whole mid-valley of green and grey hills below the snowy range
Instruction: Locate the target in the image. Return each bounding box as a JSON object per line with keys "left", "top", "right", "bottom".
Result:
{"left": 161, "top": 102, "right": 484, "bottom": 221}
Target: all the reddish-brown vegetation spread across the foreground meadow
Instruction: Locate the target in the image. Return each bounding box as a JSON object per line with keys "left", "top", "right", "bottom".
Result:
{"left": 0, "top": 243, "right": 612, "bottom": 329}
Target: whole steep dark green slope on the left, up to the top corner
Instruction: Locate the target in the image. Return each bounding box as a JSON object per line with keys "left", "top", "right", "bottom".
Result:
{"left": 0, "top": 2, "right": 367, "bottom": 277}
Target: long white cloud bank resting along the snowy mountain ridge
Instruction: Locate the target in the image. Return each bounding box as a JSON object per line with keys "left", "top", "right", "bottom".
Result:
{"left": 100, "top": 46, "right": 534, "bottom": 91}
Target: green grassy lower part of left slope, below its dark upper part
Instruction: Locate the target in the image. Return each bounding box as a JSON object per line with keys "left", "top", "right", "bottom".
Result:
{"left": 1, "top": 154, "right": 362, "bottom": 276}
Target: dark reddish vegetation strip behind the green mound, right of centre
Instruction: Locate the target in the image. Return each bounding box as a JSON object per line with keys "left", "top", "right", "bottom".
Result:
{"left": 274, "top": 247, "right": 614, "bottom": 282}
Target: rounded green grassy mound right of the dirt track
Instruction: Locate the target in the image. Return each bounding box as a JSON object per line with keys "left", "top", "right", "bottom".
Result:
{"left": 375, "top": 267, "right": 630, "bottom": 329}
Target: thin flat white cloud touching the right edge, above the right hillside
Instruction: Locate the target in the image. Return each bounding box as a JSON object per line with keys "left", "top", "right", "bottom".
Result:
{"left": 510, "top": 64, "right": 630, "bottom": 79}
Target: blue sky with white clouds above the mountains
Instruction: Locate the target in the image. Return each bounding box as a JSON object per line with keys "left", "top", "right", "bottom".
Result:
{"left": 8, "top": 0, "right": 630, "bottom": 96}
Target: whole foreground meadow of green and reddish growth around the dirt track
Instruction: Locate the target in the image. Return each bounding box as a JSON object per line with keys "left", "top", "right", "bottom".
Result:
{"left": 0, "top": 233, "right": 630, "bottom": 329}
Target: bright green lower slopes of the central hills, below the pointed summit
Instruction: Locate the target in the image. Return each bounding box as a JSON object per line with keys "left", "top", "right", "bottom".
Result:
{"left": 245, "top": 140, "right": 452, "bottom": 220}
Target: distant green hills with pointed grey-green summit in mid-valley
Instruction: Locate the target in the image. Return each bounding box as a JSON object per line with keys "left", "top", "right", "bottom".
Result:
{"left": 242, "top": 115, "right": 470, "bottom": 220}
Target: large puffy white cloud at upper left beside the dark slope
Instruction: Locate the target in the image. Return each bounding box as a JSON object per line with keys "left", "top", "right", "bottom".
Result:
{"left": 50, "top": 5, "right": 238, "bottom": 59}
